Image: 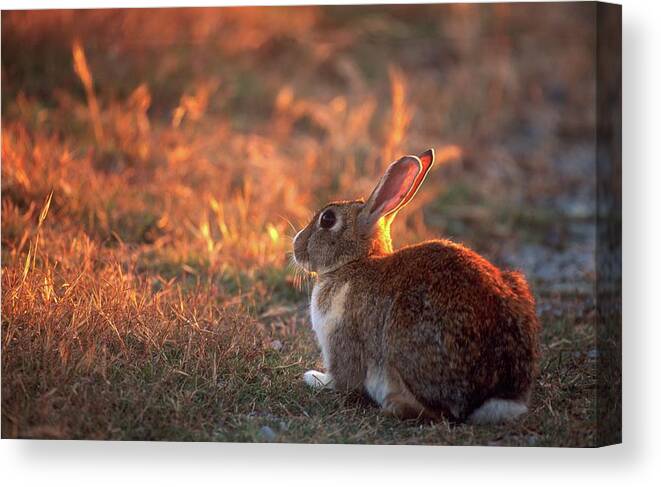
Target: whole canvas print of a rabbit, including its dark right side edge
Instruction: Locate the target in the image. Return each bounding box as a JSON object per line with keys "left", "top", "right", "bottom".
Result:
{"left": 2, "top": 2, "right": 621, "bottom": 447}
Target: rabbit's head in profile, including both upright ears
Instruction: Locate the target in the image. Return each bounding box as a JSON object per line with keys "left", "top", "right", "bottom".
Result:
{"left": 294, "top": 149, "right": 434, "bottom": 274}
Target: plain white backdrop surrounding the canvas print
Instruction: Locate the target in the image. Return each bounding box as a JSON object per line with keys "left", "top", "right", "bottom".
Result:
{"left": 0, "top": 0, "right": 661, "bottom": 487}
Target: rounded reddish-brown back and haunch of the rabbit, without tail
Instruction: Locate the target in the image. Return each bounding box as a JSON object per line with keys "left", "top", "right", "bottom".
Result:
{"left": 380, "top": 240, "right": 538, "bottom": 419}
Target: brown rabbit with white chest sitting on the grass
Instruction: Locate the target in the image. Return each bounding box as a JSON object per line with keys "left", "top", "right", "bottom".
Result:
{"left": 293, "top": 149, "right": 539, "bottom": 424}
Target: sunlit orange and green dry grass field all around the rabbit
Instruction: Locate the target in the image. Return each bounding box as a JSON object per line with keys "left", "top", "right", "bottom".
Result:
{"left": 2, "top": 5, "right": 595, "bottom": 446}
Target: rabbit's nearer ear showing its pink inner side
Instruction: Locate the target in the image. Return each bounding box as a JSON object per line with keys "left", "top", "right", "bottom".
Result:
{"left": 358, "top": 156, "right": 422, "bottom": 232}
